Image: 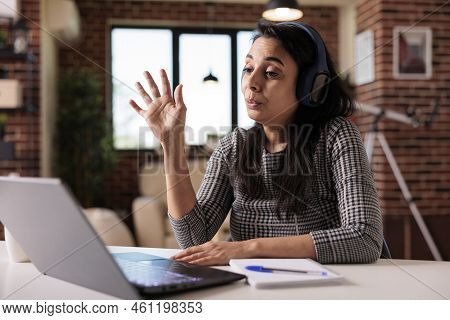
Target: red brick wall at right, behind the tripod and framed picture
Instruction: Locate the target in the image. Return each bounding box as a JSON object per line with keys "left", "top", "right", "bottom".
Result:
{"left": 357, "top": 0, "right": 450, "bottom": 260}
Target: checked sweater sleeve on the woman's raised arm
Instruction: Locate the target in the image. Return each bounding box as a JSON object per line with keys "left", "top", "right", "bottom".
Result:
{"left": 168, "top": 136, "right": 234, "bottom": 249}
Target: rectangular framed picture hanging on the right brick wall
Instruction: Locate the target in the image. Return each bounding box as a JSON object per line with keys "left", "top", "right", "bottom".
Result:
{"left": 393, "top": 26, "right": 432, "bottom": 80}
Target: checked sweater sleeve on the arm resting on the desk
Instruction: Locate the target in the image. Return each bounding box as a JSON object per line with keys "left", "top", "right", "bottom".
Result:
{"left": 310, "top": 120, "right": 383, "bottom": 263}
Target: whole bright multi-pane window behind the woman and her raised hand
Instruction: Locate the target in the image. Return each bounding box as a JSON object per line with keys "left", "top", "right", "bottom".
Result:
{"left": 111, "top": 27, "right": 253, "bottom": 150}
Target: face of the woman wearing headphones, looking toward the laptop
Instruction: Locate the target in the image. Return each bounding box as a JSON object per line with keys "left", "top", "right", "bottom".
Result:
{"left": 241, "top": 37, "right": 298, "bottom": 126}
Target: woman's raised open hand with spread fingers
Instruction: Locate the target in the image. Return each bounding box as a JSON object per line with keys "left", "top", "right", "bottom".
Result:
{"left": 130, "top": 70, "right": 186, "bottom": 145}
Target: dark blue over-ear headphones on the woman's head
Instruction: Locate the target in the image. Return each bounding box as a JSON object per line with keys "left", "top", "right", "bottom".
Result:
{"left": 278, "top": 22, "right": 330, "bottom": 108}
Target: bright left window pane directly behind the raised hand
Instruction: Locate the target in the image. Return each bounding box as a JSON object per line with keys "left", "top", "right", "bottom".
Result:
{"left": 111, "top": 28, "right": 173, "bottom": 149}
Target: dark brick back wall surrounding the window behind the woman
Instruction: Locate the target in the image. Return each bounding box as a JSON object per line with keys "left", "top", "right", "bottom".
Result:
{"left": 59, "top": 0, "right": 338, "bottom": 228}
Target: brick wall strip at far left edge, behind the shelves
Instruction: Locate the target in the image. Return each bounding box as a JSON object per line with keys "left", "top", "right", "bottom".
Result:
{"left": 0, "top": 0, "right": 40, "bottom": 239}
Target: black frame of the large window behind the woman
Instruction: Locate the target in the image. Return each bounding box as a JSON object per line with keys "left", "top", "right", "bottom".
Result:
{"left": 106, "top": 23, "right": 255, "bottom": 152}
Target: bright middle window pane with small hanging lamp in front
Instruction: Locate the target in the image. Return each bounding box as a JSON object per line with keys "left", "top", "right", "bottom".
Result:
{"left": 180, "top": 34, "right": 231, "bottom": 144}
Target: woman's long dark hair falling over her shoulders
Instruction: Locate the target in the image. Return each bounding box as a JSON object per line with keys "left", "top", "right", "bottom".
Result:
{"left": 233, "top": 23, "right": 354, "bottom": 215}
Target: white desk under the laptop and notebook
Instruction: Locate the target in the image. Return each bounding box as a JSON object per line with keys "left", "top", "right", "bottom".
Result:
{"left": 0, "top": 241, "right": 450, "bottom": 300}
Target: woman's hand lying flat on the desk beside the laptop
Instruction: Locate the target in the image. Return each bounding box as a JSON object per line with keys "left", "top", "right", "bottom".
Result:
{"left": 171, "top": 241, "right": 251, "bottom": 266}
